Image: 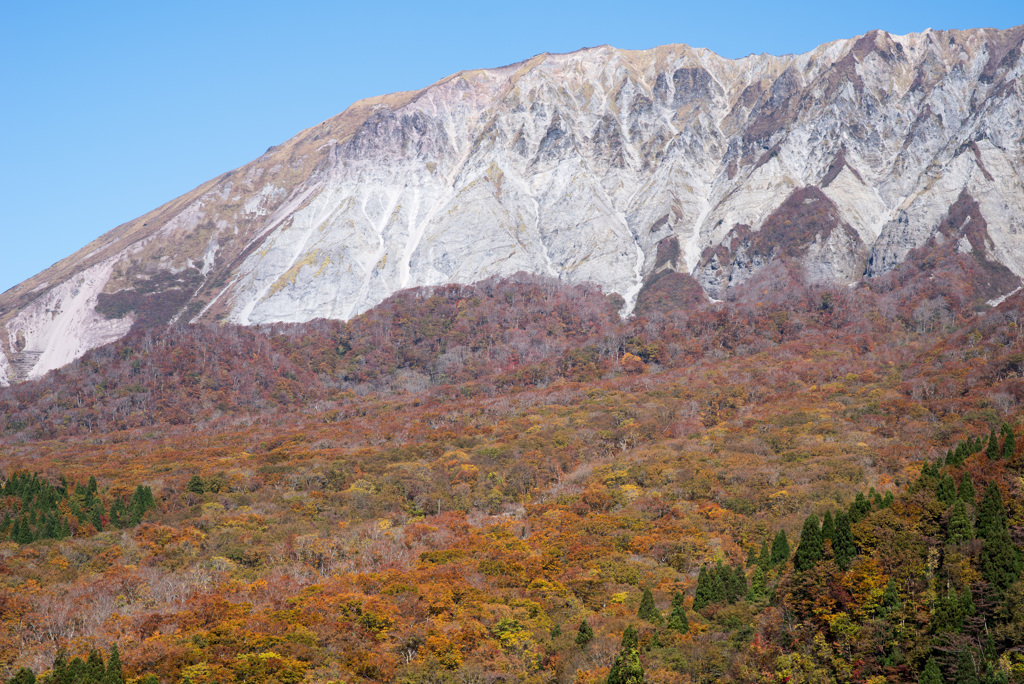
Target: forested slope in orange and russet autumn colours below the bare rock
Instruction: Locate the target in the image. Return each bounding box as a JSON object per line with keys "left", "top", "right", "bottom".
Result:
{"left": 0, "top": 264, "right": 1024, "bottom": 682}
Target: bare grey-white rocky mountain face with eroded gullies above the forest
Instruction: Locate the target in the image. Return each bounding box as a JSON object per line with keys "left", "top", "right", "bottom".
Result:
{"left": 0, "top": 27, "right": 1024, "bottom": 384}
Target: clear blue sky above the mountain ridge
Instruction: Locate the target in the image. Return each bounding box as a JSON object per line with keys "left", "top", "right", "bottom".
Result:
{"left": 0, "top": 0, "right": 1024, "bottom": 292}
